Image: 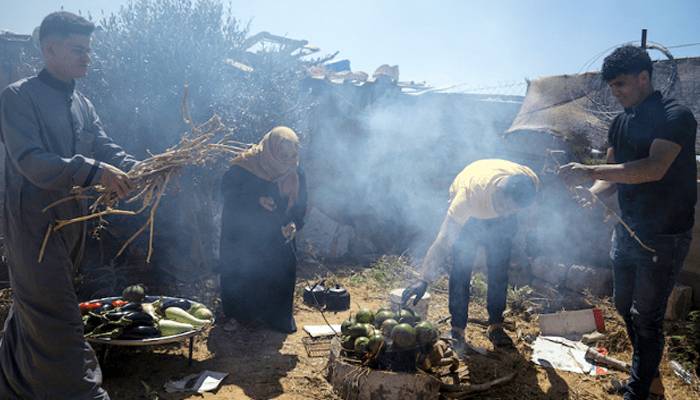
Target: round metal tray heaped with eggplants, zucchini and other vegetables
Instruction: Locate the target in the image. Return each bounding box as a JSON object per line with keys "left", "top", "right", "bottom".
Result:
{"left": 80, "top": 285, "right": 214, "bottom": 346}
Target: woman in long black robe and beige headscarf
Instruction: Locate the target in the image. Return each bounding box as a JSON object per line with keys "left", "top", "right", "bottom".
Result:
{"left": 220, "top": 127, "right": 307, "bottom": 333}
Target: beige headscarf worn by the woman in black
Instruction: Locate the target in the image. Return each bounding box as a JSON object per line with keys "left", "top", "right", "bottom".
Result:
{"left": 233, "top": 126, "right": 299, "bottom": 210}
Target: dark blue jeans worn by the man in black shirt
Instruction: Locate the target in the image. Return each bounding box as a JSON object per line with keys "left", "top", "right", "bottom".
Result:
{"left": 610, "top": 226, "right": 691, "bottom": 400}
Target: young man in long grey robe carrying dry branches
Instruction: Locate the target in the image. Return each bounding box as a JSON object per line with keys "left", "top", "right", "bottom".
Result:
{"left": 0, "top": 12, "right": 136, "bottom": 400}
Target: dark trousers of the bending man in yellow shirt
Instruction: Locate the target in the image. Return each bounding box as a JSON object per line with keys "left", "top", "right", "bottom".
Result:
{"left": 449, "top": 216, "right": 518, "bottom": 329}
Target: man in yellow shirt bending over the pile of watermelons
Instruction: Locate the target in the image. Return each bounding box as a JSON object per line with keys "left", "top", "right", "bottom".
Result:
{"left": 402, "top": 159, "right": 540, "bottom": 349}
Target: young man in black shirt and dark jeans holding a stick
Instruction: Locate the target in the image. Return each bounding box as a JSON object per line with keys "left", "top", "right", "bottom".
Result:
{"left": 560, "top": 46, "right": 697, "bottom": 400}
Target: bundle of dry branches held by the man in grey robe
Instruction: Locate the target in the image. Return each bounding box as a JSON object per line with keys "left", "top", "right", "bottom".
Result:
{"left": 39, "top": 87, "right": 251, "bottom": 262}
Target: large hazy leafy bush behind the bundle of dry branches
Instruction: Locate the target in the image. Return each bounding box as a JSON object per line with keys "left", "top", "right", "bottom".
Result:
{"left": 82, "top": 0, "right": 307, "bottom": 156}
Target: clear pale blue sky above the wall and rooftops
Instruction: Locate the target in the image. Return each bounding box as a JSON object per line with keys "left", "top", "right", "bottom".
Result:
{"left": 0, "top": 0, "right": 700, "bottom": 94}
